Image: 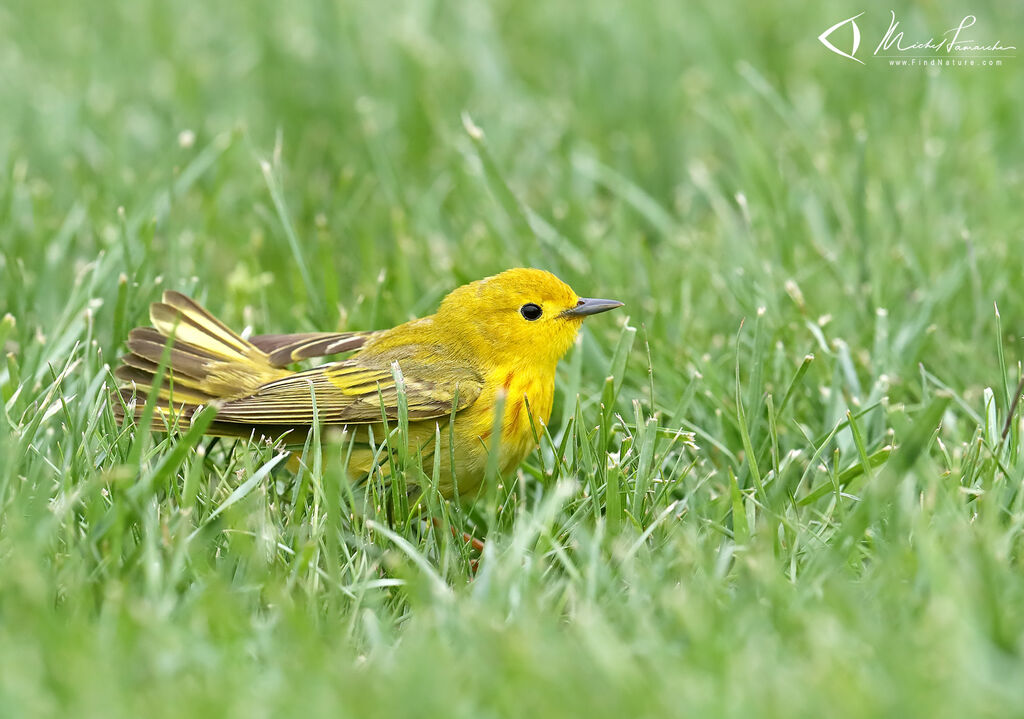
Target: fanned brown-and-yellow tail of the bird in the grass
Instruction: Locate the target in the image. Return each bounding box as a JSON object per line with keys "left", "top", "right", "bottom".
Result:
{"left": 114, "top": 291, "right": 292, "bottom": 427}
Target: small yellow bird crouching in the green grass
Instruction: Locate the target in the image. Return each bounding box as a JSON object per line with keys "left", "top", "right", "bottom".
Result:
{"left": 115, "top": 269, "right": 623, "bottom": 498}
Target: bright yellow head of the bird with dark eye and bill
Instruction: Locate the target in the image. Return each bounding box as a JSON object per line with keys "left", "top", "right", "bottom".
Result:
{"left": 435, "top": 268, "right": 623, "bottom": 364}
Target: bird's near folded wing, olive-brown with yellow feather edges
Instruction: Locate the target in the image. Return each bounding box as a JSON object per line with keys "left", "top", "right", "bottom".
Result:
{"left": 211, "top": 352, "right": 483, "bottom": 425}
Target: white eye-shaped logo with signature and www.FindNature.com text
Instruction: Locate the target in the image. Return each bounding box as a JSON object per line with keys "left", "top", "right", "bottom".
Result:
{"left": 818, "top": 10, "right": 1017, "bottom": 67}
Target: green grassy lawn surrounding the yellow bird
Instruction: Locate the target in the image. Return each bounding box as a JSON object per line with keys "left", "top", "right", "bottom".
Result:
{"left": 0, "top": 0, "right": 1024, "bottom": 719}
